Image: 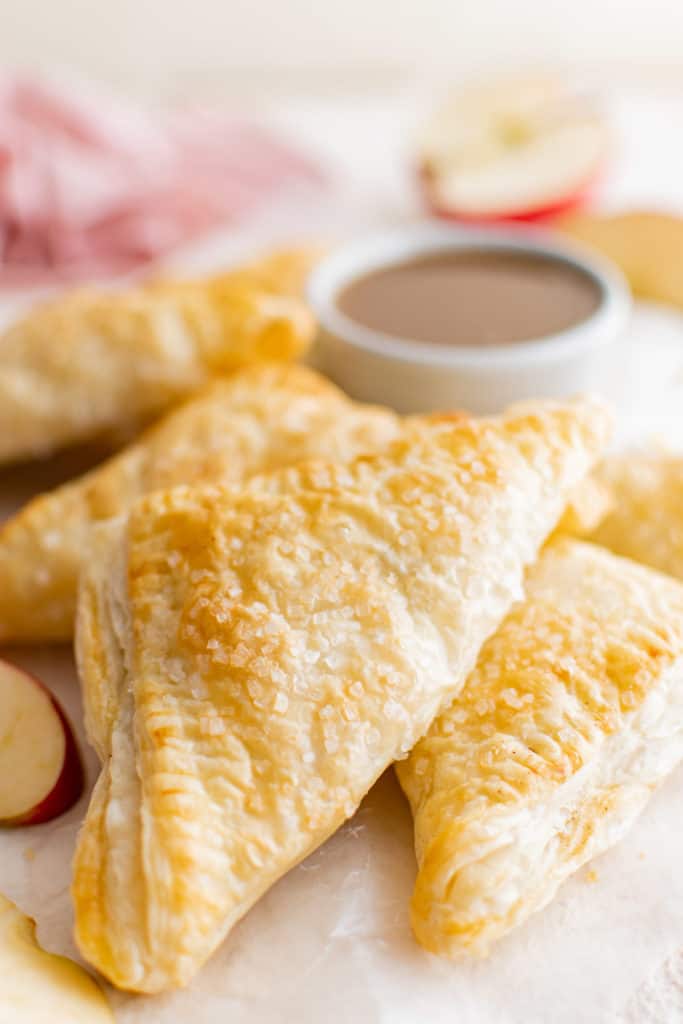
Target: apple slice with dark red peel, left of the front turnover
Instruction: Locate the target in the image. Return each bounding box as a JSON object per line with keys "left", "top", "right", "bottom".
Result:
{"left": 0, "top": 662, "right": 83, "bottom": 826}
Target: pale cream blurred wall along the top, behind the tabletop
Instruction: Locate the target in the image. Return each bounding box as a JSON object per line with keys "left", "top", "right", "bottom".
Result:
{"left": 0, "top": 0, "right": 683, "bottom": 99}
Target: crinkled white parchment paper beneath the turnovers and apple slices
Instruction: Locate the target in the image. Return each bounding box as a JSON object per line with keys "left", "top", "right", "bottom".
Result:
{"left": 0, "top": 299, "right": 683, "bottom": 1024}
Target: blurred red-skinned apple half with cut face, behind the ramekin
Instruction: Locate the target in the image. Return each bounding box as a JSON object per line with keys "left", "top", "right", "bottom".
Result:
{"left": 418, "top": 75, "right": 609, "bottom": 221}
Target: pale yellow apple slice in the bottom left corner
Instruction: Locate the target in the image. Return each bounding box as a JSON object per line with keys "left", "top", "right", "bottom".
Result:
{"left": 0, "top": 895, "right": 114, "bottom": 1024}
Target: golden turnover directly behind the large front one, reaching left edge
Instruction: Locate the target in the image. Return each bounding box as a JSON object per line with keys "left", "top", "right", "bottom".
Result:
{"left": 0, "top": 364, "right": 400, "bottom": 642}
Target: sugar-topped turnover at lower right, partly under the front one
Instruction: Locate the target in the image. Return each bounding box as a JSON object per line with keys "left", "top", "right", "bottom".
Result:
{"left": 396, "top": 540, "right": 683, "bottom": 956}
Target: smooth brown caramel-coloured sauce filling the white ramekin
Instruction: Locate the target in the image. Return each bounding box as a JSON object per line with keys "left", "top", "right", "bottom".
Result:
{"left": 336, "top": 248, "right": 601, "bottom": 347}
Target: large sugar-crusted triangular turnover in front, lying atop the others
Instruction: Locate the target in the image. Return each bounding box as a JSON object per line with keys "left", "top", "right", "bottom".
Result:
{"left": 73, "top": 400, "right": 609, "bottom": 992}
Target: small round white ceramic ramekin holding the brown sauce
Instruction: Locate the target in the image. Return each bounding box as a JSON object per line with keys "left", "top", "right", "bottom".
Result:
{"left": 308, "top": 223, "right": 631, "bottom": 413}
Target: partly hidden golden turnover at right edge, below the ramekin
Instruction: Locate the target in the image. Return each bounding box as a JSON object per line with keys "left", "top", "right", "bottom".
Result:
{"left": 591, "top": 452, "right": 683, "bottom": 580}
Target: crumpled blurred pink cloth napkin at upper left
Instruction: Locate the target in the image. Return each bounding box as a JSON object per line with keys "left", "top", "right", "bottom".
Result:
{"left": 0, "top": 79, "right": 322, "bottom": 285}
